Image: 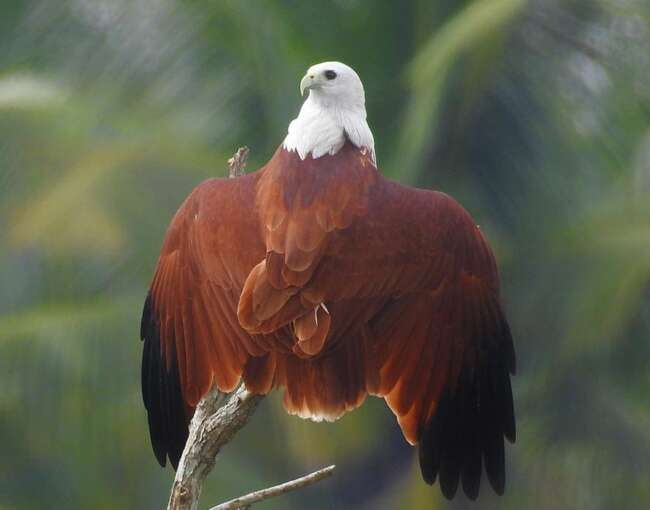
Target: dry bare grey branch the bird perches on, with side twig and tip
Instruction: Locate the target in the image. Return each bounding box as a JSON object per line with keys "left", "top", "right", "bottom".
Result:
{"left": 167, "top": 147, "right": 334, "bottom": 510}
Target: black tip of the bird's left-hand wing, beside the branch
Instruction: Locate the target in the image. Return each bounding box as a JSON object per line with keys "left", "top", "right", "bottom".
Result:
{"left": 140, "top": 295, "right": 189, "bottom": 469}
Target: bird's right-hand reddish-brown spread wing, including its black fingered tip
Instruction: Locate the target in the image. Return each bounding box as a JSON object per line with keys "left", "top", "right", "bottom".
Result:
{"left": 302, "top": 179, "right": 515, "bottom": 498}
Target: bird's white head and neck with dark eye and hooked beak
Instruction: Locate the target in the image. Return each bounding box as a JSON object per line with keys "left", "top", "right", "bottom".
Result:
{"left": 283, "top": 62, "right": 375, "bottom": 162}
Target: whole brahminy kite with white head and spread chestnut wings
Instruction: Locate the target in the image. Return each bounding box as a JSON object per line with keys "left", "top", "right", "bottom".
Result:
{"left": 141, "top": 62, "right": 515, "bottom": 499}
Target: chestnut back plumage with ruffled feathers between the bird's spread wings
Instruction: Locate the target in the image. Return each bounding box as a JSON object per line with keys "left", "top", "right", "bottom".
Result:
{"left": 238, "top": 144, "right": 378, "bottom": 357}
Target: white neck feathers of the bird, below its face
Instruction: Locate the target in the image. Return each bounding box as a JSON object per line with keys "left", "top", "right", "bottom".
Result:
{"left": 282, "top": 92, "right": 377, "bottom": 166}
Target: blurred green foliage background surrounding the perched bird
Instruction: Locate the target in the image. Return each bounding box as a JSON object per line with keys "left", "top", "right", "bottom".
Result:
{"left": 0, "top": 0, "right": 650, "bottom": 509}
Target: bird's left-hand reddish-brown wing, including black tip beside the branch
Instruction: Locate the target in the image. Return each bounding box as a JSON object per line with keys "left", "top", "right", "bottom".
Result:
{"left": 141, "top": 174, "right": 265, "bottom": 467}
